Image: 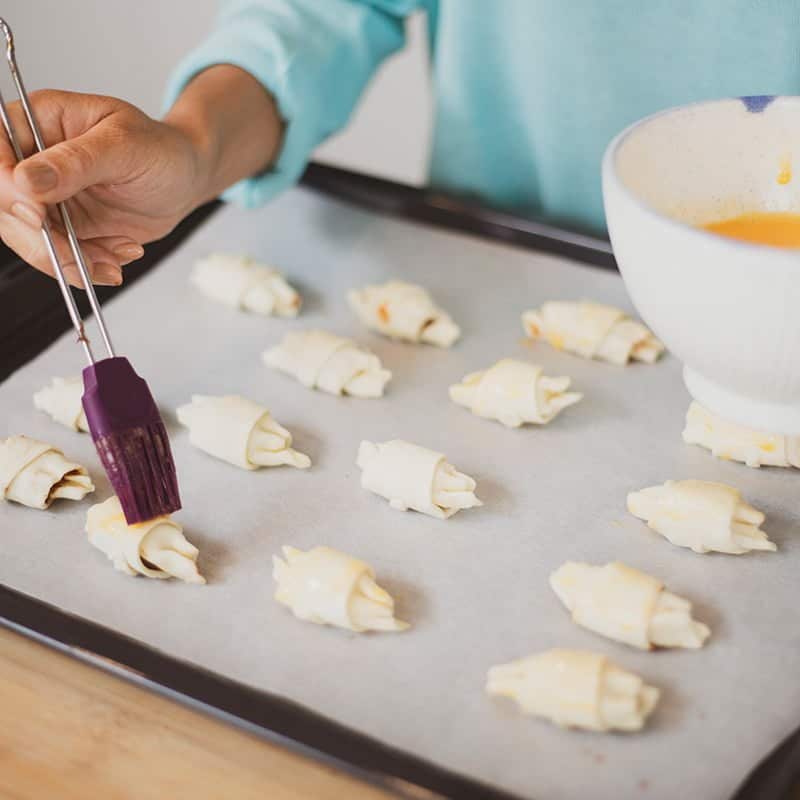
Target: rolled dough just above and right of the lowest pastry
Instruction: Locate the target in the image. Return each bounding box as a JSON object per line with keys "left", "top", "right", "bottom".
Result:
{"left": 550, "top": 561, "right": 711, "bottom": 650}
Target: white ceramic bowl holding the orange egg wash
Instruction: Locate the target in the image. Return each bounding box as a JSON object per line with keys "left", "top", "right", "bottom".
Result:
{"left": 603, "top": 97, "right": 800, "bottom": 434}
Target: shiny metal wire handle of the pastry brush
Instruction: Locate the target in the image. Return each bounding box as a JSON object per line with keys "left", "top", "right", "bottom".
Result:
{"left": 0, "top": 18, "right": 114, "bottom": 364}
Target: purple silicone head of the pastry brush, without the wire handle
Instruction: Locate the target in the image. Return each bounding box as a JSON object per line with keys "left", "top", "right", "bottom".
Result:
{"left": 83, "top": 356, "right": 181, "bottom": 525}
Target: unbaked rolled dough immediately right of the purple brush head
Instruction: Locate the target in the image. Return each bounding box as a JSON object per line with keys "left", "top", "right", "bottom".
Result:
{"left": 177, "top": 394, "right": 311, "bottom": 469}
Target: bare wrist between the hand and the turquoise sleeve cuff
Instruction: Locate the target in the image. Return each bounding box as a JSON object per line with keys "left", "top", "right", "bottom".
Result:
{"left": 164, "top": 64, "right": 284, "bottom": 206}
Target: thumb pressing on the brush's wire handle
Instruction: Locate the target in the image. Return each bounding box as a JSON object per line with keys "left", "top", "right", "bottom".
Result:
{"left": 14, "top": 123, "right": 128, "bottom": 203}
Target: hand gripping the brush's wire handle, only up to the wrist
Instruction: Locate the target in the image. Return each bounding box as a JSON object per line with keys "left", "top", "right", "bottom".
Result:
{"left": 0, "top": 91, "right": 205, "bottom": 286}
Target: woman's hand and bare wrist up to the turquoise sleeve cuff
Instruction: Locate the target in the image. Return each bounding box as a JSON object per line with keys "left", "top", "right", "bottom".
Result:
{"left": 0, "top": 64, "right": 283, "bottom": 286}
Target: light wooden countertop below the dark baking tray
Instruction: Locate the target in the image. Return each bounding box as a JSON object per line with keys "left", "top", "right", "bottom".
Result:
{"left": 0, "top": 628, "right": 392, "bottom": 800}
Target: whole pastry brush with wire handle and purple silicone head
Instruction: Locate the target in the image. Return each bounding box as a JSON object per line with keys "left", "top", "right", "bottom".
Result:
{"left": 0, "top": 19, "right": 181, "bottom": 524}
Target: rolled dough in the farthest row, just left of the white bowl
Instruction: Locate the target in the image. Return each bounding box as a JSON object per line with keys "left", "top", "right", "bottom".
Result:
{"left": 522, "top": 301, "right": 664, "bottom": 365}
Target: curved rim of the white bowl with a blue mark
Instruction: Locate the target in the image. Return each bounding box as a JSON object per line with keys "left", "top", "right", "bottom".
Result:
{"left": 601, "top": 94, "right": 800, "bottom": 260}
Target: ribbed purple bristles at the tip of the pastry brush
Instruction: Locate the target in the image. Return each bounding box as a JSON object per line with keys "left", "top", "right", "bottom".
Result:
{"left": 95, "top": 422, "right": 181, "bottom": 525}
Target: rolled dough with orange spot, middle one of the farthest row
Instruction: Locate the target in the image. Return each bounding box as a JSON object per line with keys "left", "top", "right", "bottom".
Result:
{"left": 347, "top": 281, "right": 461, "bottom": 347}
